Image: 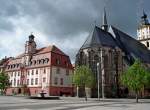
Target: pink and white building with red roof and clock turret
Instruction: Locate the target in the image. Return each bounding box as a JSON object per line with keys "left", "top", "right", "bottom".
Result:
{"left": 1, "top": 34, "right": 73, "bottom": 96}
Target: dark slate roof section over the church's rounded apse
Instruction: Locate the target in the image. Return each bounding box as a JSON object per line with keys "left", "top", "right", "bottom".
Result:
{"left": 81, "top": 26, "right": 117, "bottom": 49}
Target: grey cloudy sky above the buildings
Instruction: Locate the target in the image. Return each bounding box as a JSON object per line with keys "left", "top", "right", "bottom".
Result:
{"left": 0, "top": 0, "right": 150, "bottom": 62}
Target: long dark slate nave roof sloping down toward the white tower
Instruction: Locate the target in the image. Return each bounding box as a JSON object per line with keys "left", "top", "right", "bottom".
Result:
{"left": 109, "top": 26, "right": 150, "bottom": 63}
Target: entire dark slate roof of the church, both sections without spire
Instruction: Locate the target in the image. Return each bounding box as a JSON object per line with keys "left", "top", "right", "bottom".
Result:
{"left": 80, "top": 26, "right": 150, "bottom": 64}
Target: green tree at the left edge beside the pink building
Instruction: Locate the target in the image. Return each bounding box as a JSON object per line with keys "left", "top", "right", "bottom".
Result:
{"left": 0, "top": 71, "right": 10, "bottom": 94}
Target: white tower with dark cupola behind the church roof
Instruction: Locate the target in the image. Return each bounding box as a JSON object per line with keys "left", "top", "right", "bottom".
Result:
{"left": 137, "top": 12, "right": 150, "bottom": 50}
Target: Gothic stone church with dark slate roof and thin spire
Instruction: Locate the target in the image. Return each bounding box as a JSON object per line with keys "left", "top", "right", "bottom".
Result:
{"left": 76, "top": 10, "right": 150, "bottom": 97}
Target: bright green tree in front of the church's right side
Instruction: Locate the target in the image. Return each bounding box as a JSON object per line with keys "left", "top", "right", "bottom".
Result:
{"left": 121, "top": 60, "right": 150, "bottom": 102}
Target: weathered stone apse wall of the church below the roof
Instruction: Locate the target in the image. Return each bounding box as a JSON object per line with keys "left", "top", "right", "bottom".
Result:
{"left": 76, "top": 47, "right": 124, "bottom": 97}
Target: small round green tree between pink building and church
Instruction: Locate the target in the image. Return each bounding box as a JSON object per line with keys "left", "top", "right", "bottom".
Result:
{"left": 73, "top": 65, "right": 95, "bottom": 100}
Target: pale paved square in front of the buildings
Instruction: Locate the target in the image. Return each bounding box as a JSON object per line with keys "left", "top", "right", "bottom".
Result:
{"left": 0, "top": 96, "right": 150, "bottom": 110}
